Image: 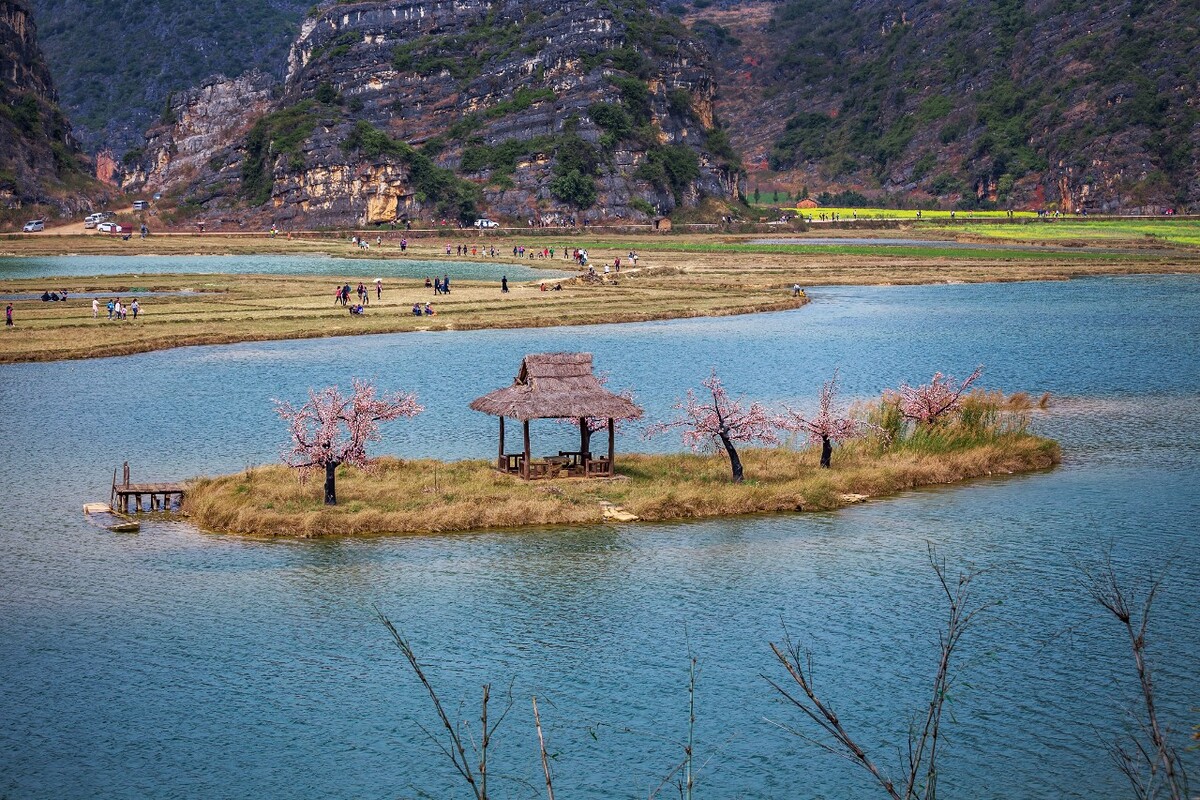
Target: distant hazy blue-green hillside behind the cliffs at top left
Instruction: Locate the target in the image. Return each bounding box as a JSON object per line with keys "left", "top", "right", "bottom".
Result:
{"left": 29, "top": 0, "right": 313, "bottom": 156}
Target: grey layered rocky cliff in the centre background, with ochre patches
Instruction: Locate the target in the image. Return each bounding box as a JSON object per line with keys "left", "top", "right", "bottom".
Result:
{"left": 134, "top": 0, "right": 742, "bottom": 227}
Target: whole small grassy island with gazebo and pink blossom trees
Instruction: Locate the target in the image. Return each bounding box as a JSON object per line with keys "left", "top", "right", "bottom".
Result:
{"left": 184, "top": 354, "right": 1061, "bottom": 537}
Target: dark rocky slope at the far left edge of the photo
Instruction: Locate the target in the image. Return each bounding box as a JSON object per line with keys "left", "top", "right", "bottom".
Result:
{"left": 0, "top": 0, "right": 94, "bottom": 222}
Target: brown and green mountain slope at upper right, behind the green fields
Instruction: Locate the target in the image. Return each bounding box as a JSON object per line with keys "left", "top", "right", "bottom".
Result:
{"left": 680, "top": 0, "right": 1200, "bottom": 211}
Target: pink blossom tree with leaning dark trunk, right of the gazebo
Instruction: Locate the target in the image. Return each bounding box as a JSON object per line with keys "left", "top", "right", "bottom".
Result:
{"left": 646, "top": 369, "right": 779, "bottom": 483}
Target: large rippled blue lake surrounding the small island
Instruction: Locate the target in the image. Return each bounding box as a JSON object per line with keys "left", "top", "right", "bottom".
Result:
{"left": 0, "top": 277, "right": 1200, "bottom": 799}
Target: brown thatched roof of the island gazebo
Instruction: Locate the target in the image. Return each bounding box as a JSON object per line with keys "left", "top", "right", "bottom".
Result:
{"left": 470, "top": 353, "right": 642, "bottom": 421}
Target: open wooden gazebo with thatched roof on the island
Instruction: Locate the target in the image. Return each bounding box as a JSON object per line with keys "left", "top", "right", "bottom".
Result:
{"left": 470, "top": 353, "right": 642, "bottom": 480}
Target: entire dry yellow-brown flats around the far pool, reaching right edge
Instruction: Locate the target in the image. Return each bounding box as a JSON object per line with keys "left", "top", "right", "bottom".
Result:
{"left": 0, "top": 231, "right": 1200, "bottom": 363}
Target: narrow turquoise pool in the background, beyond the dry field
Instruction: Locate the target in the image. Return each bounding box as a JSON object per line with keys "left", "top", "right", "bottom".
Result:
{"left": 0, "top": 256, "right": 569, "bottom": 288}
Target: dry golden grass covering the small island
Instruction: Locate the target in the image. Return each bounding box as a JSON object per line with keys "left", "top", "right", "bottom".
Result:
{"left": 185, "top": 396, "right": 1061, "bottom": 537}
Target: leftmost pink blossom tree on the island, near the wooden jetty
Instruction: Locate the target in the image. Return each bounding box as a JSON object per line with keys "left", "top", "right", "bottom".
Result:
{"left": 275, "top": 378, "right": 425, "bottom": 505}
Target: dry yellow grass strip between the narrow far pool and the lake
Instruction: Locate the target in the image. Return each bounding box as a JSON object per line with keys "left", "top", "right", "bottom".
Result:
{"left": 0, "top": 275, "right": 806, "bottom": 363}
